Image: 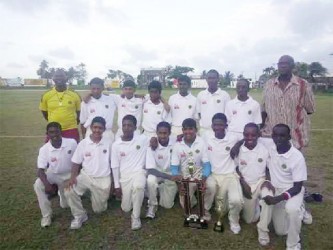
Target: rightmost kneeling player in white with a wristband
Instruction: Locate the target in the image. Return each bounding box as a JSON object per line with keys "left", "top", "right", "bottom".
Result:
{"left": 263, "top": 124, "right": 307, "bottom": 249}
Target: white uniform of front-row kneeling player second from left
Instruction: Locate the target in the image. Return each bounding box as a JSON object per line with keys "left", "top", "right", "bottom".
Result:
{"left": 65, "top": 137, "right": 112, "bottom": 217}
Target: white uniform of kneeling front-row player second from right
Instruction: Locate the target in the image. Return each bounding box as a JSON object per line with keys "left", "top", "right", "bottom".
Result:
{"left": 236, "top": 142, "right": 273, "bottom": 232}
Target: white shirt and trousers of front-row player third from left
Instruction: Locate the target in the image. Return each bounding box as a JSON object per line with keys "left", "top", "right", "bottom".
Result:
{"left": 111, "top": 135, "right": 148, "bottom": 219}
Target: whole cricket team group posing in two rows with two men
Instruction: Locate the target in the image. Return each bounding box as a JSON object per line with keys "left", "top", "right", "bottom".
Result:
{"left": 34, "top": 55, "right": 314, "bottom": 249}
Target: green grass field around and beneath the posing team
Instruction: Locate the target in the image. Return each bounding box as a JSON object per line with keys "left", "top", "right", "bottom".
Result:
{"left": 0, "top": 90, "right": 333, "bottom": 249}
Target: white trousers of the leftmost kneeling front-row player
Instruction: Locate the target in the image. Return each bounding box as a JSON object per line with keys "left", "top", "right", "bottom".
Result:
{"left": 34, "top": 170, "right": 71, "bottom": 217}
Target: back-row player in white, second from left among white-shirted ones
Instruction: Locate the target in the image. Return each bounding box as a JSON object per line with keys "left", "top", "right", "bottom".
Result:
{"left": 112, "top": 80, "right": 144, "bottom": 138}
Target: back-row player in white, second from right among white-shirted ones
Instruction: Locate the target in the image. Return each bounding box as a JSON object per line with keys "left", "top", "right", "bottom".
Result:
{"left": 197, "top": 69, "right": 230, "bottom": 136}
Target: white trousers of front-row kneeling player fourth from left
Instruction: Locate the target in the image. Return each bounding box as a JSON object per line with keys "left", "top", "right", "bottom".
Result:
{"left": 147, "top": 174, "right": 178, "bottom": 208}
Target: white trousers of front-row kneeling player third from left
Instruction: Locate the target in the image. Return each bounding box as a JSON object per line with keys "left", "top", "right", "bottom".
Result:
{"left": 120, "top": 170, "right": 146, "bottom": 219}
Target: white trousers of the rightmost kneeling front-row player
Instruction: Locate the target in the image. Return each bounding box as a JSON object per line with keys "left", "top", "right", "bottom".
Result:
{"left": 272, "top": 187, "right": 305, "bottom": 248}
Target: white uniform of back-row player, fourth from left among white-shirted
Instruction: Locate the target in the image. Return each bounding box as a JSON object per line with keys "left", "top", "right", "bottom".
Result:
{"left": 169, "top": 92, "right": 197, "bottom": 135}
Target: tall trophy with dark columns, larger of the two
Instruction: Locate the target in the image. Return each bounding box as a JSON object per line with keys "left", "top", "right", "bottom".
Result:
{"left": 181, "top": 152, "right": 208, "bottom": 229}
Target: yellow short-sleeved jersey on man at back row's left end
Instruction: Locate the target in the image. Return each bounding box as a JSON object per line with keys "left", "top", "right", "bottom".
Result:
{"left": 39, "top": 88, "right": 81, "bottom": 130}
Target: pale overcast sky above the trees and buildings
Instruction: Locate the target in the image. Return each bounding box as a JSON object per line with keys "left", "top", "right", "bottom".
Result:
{"left": 0, "top": 0, "right": 333, "bottom": 80}
